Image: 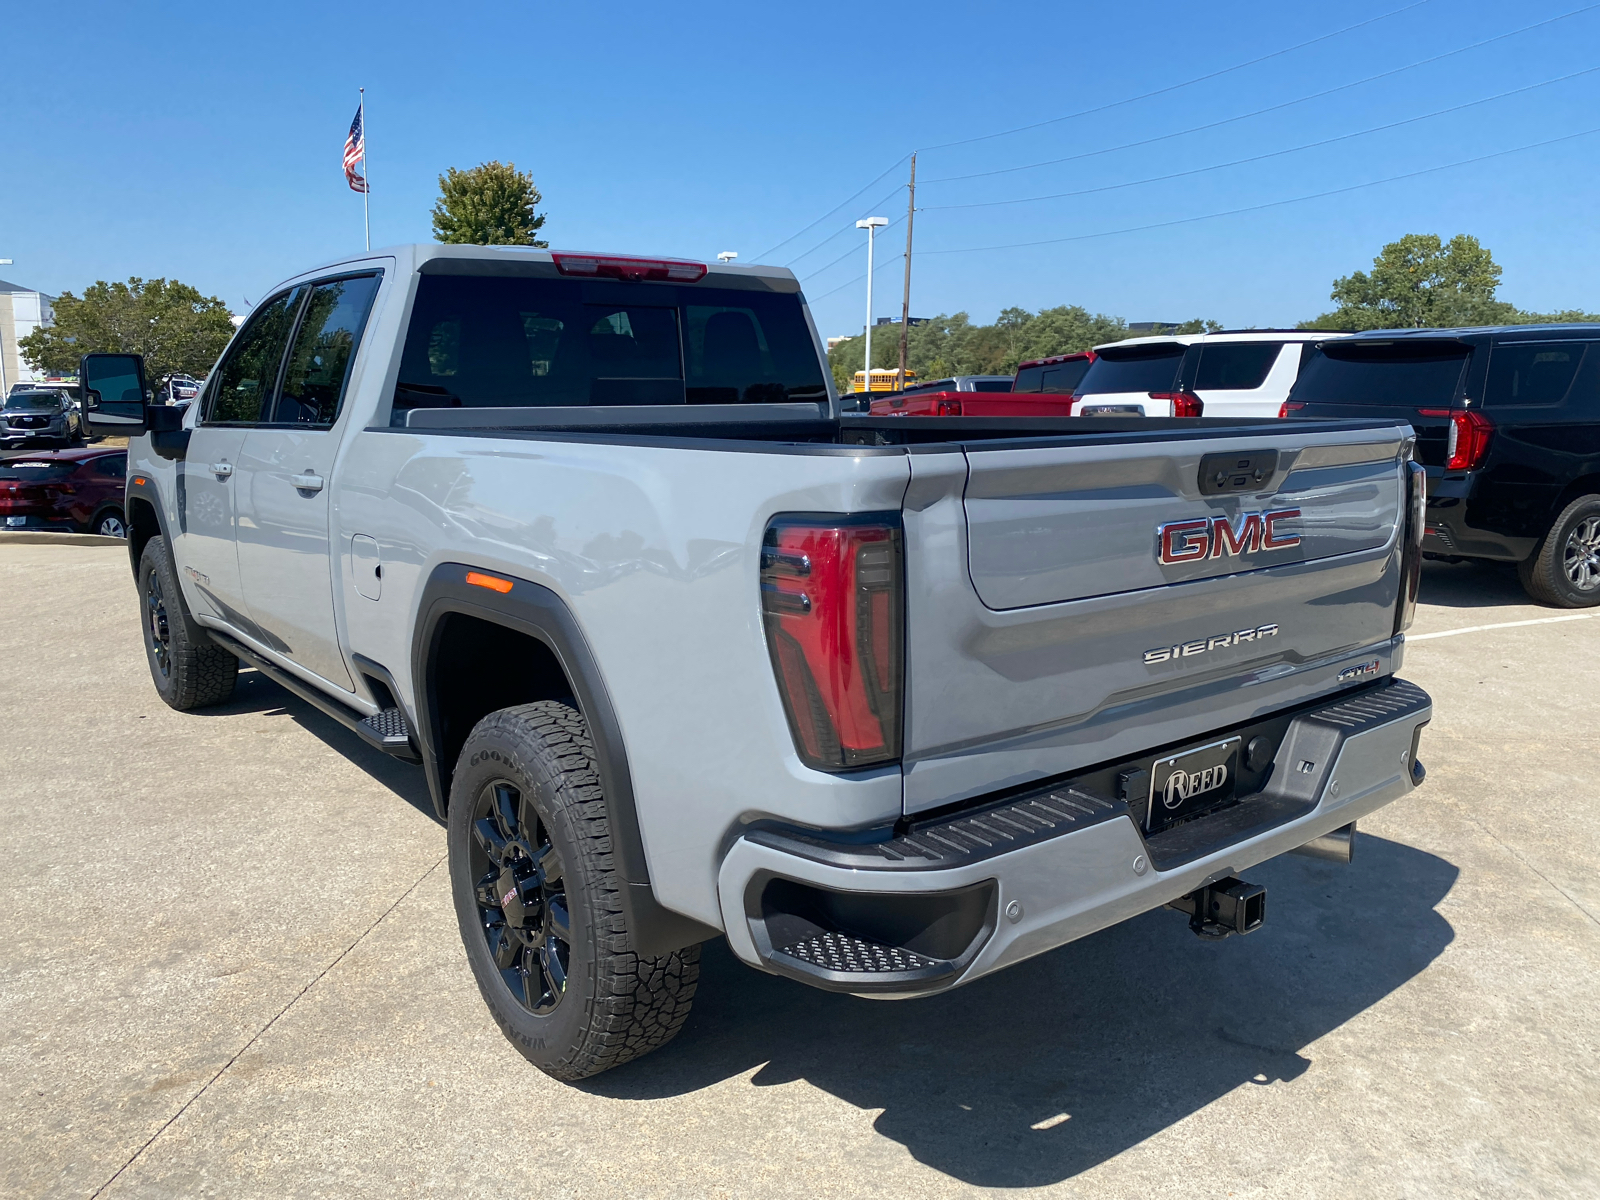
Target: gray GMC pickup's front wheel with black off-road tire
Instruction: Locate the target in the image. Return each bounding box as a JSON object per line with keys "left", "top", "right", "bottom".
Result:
{"left": 139, "top": 538, "right": 238, "bottom": 712}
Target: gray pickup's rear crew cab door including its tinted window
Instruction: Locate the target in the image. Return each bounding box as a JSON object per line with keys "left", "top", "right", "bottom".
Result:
{"left": 235, "top": 274, "right": 379, "bottom": 690}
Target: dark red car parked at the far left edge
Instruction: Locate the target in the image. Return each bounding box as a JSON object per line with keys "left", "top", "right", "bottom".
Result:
{"left": 0, "top": 446, "right": 128, "bottom": 538}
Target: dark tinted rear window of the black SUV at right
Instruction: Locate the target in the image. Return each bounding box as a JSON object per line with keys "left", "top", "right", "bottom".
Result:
{"left": 1290, "top": 341, "right": 1472, "bottom": 408}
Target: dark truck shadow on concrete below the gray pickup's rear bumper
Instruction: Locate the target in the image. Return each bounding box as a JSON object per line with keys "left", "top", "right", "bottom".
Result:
{"left": 584, "top": 835, "right": 1458, "bottom": 1187}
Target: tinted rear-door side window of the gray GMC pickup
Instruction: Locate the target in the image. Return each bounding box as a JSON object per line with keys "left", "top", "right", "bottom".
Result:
{"left": 269, "top": 275, "right": 379, "bottom": 429}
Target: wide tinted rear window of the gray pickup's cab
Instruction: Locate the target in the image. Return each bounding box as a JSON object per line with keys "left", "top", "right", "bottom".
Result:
{"left": 395, "top": 275, "right": 827, "bottom": 419}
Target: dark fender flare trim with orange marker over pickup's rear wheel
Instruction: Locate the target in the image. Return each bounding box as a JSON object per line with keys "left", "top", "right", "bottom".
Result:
{"left": 411, "top": 563, "right": 718, "bottom": 957}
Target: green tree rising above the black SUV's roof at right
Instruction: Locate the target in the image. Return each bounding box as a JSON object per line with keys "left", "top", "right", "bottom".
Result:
{"left": 1301, "top": 234, "right": 1520, "bottom": 330}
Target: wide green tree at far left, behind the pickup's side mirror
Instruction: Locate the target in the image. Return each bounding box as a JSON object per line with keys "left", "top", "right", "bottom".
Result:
{"left": 18, "top": 278, "right": 234, "bottom": 384}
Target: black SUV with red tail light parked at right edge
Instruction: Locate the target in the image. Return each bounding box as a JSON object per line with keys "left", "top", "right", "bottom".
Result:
{"left": 1283, "top": 325, "right": 1600, "bottom": 608}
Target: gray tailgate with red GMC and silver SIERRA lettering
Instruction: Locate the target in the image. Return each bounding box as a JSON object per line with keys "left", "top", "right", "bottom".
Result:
{"left": 906, "top": 424, "right": 1410, "bottom": 813}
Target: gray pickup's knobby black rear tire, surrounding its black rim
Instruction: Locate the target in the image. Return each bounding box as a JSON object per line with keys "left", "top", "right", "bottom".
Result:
{"left": 446, "top": 701, "right": 699, "bottom": 1082}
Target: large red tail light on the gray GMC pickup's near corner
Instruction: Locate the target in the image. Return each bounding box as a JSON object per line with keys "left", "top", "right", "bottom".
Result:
{"left": 762, "top": 515, "right": 906, "bottom": 771}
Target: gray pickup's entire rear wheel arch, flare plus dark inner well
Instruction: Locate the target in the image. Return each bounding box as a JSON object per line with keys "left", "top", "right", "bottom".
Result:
{"left": 411, "top": 563, "right": 717, "bottom": 955}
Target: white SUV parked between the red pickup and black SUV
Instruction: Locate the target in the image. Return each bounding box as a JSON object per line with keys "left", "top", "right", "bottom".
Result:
{"left": 1072, "top": 330, "right": 1347, "bottom": 416}
